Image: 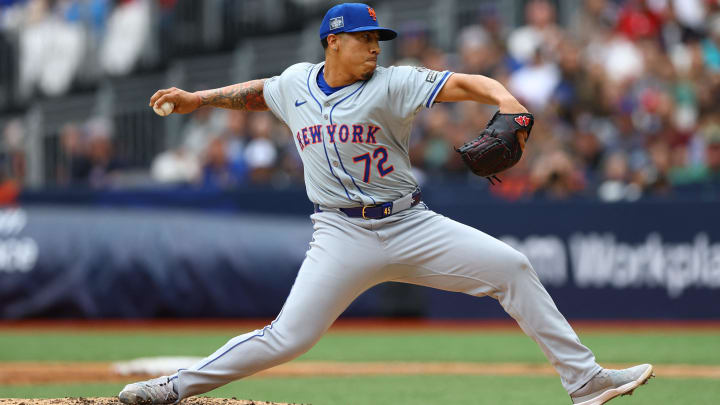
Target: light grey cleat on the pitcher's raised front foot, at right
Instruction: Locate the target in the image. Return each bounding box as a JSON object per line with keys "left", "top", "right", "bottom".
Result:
{"left": 570, "top": 364, "right": 655, "bottom": 405}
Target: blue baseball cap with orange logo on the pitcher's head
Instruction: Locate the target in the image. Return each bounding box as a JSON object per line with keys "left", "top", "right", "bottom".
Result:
{"left": 320, "top": 3, "right": 397, "bottom": 41}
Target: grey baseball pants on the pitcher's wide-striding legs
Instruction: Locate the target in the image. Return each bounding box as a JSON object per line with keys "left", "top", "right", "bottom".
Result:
{"left": 172, "top": 204, "right": 600, "bottom": 399}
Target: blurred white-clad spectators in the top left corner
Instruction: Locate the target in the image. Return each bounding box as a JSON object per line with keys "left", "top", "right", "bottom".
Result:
{"left": 0, "top": 0, "right": 176, "bottom": 99}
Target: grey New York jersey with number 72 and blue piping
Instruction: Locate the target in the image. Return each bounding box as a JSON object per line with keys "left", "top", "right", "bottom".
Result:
{"left": 264, "top": 62, "right": 452, "bottom": 208}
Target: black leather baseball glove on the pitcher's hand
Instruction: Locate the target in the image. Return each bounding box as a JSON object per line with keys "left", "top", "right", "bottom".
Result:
{"left": 455, "top": 111, "right": 535, "bottom": 183}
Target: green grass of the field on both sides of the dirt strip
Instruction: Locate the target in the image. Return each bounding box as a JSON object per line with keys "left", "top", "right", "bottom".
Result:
{"left": 0, "top": 329, "right": 720, "bottom": 405}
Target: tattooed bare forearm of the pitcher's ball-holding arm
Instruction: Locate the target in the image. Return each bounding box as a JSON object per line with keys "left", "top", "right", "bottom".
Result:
{"left": 197, "top": 79, "right": 268, "bottom": 111}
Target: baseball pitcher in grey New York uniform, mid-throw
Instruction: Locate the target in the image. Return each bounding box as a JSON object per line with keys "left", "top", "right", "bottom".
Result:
{"left": 119, "top": 3, "right": 653, "bottom": 405}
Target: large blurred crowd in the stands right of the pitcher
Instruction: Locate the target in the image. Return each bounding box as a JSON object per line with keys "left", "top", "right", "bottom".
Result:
{"left": 399, "top": 0, "right": 720, "bottom": 201}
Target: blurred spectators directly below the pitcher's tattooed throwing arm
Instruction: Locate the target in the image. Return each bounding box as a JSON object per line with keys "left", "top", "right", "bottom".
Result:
{"left": 151, "top": 107, "right": 303, "bottom": 189}
